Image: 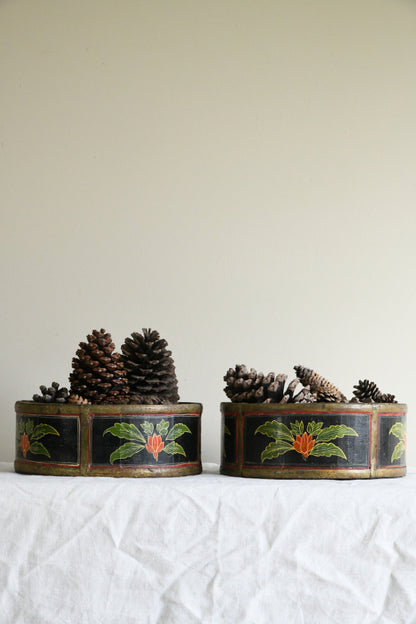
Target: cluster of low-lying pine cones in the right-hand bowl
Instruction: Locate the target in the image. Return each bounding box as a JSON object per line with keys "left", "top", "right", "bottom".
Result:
{"left": 224, "top": 364, "right": 397, "bottom": 403}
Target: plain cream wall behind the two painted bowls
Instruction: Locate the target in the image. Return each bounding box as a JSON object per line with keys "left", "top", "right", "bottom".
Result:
{"left": 0, "top": 0, "right": 416, "bottom": 464}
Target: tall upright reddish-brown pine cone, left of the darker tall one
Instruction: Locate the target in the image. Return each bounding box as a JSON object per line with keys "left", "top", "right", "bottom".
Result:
{"left": 69, "top": 329, "right": 129, "bottom": 404}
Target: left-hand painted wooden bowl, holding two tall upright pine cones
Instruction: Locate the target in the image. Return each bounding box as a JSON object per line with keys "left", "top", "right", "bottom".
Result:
{"left": 14, "top": 401, "right": 202, "bottom": 477}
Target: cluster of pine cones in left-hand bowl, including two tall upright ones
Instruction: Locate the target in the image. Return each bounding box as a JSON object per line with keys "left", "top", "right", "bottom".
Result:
{"left": 33, "top": 329, "right": 179, "bottom": 404}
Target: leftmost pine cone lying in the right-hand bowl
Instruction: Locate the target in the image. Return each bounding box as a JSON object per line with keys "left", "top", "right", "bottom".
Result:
{"left": 224, "top": 364, "right": 275, "bottom": 403}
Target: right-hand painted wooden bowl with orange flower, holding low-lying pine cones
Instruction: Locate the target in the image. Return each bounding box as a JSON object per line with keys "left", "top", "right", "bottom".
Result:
{"left": 221, "top": 403, "right": 407, "bottom": 479}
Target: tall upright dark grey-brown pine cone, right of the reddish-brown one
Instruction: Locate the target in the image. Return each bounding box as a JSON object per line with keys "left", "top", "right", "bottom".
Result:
{"left": 121, "top": 329, "right": 179, "bottom": 404}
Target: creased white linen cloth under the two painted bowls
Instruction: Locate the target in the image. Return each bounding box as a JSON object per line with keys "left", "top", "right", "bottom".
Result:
{"left": 0, "top": 463, "right": 416, "bottom": 624}
